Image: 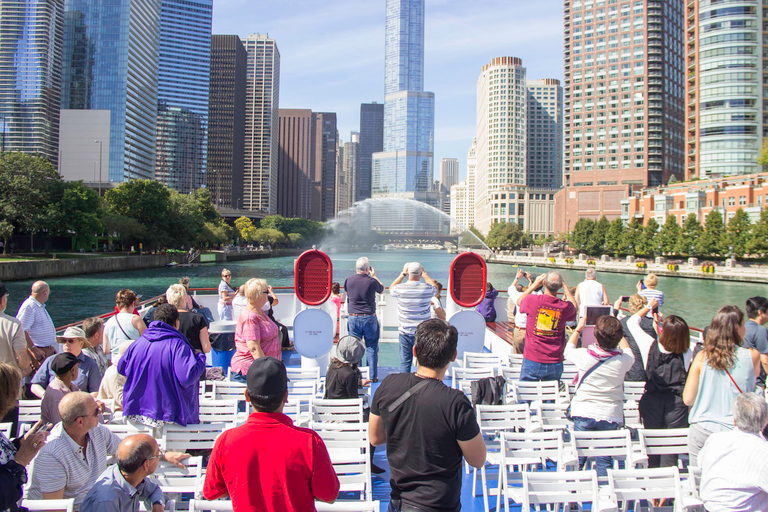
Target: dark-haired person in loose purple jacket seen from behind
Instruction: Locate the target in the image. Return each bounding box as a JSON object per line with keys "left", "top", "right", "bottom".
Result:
{"left": 117, "top": 304, "right": 205, "bottom": 427}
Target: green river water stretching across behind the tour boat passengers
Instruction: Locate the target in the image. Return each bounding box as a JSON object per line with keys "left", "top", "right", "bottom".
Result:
{"left": 6, "top": 250, "right": 768, "bottom": 327}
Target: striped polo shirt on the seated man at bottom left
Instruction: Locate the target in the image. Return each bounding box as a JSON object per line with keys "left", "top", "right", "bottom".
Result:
{"left": 29, "top": 423, "right": 120, "bottom": 511}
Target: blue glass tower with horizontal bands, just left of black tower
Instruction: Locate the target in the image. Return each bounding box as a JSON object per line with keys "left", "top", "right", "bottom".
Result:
{"left": 155, "top": 0, "right": 213, "bottom": 194}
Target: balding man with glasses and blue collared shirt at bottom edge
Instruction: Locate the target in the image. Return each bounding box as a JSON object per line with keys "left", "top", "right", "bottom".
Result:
{"left": 80, "top": 434, "right": 165, "bottom": 512}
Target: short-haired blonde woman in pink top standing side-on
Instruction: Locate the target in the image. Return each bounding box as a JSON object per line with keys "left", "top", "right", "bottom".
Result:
{"left": 231, "top": 279, "right": 282, "bottom": 382}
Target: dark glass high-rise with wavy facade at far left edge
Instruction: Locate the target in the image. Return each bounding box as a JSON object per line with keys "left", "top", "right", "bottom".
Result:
{"left": 0, "top": 0, "right": 64, "bottom": 165}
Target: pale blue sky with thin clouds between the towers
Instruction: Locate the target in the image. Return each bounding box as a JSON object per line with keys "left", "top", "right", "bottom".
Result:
{"left": 213, "top": 0, "right": 563, "bottom": 179}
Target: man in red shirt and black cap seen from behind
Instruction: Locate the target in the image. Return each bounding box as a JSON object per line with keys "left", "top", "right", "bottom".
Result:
{"left": 203, "top": 357, "right": 339, "bottom": 512}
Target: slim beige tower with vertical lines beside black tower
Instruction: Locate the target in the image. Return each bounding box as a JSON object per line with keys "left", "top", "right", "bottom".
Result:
{"left": 243, "top": 34, "right": 280, "bottom": 215}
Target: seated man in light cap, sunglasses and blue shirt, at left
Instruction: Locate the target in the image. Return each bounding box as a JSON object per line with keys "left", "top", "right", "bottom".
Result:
{"left": 31, "top": 327, "right": 101, "bottom": 398}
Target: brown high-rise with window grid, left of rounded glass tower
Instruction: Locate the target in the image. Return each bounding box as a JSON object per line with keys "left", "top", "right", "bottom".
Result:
{"left": 557, "top": 0, "right": 685, "bottom": 232}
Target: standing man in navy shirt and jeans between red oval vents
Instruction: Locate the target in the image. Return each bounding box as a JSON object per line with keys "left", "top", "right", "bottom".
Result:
{"left": 344, "top": 256, "right": 384, "bottom": 382}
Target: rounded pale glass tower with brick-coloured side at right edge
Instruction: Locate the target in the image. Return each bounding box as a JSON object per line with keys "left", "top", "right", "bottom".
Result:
{"left": 686, "top": 0, "right": 768, "bottom": 179}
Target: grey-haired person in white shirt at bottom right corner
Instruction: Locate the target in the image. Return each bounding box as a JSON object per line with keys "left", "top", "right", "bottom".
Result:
{"left": 699, "top": 393, "right": 768, "bottom": 512}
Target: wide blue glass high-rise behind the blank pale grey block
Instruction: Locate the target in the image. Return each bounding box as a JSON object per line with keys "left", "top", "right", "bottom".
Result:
{"left": 61, "top": 0, "right": 160, "bottom": 183}
